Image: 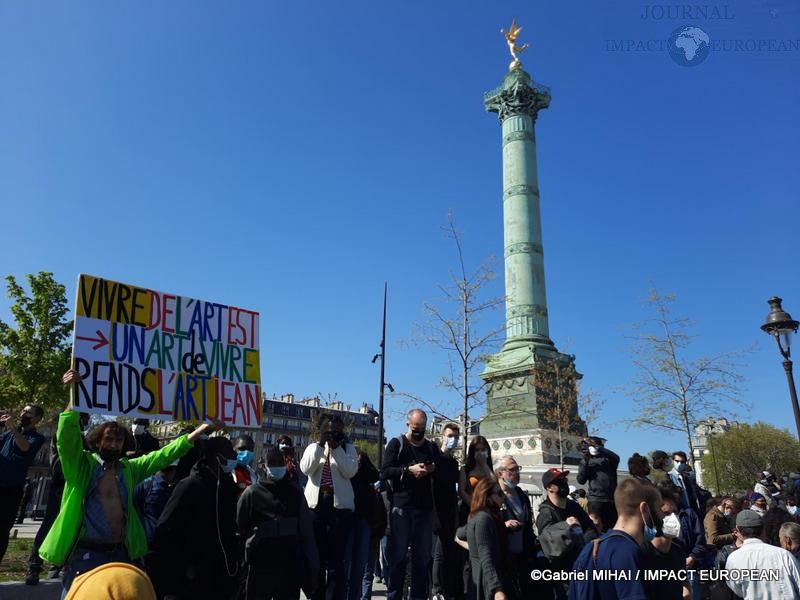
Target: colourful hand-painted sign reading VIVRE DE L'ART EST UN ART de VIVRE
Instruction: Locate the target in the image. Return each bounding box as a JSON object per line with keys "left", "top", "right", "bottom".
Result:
{"left": 73, "top": 275, "right": 261, "bottom": 427}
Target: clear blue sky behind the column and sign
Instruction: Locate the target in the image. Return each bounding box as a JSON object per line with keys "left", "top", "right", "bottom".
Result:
{"left": 0, "top": 0, "right": 800, "bottom": 466}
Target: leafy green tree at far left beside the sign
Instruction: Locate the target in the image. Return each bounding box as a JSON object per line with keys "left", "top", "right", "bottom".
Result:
{"left": 0, "top": 272, "right": 72, "bottom": 410}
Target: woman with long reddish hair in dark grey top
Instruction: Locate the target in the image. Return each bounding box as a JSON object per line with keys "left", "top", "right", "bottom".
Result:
{"left": 467, "top": 477, "right": 511, "bottom": 600}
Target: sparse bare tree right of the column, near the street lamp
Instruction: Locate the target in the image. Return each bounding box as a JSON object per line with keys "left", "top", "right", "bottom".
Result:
{"left": 627, "top": 289, "right": 746, "bottom": 462}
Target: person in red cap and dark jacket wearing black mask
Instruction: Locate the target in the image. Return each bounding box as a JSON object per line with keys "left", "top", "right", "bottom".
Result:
{"left": 536, "top": 467, "right": 598, "bottom": 598}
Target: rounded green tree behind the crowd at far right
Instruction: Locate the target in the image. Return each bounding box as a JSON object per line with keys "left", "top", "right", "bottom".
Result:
{"left": 702, "top": 422, "right": 800, "bottom": 493}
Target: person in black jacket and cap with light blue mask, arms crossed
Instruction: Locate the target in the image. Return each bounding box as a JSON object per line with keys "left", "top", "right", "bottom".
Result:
{"left": 236, "top": 447, "right": 319, "bottom": 600}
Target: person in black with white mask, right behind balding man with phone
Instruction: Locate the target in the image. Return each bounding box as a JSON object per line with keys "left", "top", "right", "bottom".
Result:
{"left": 432, "top": 423, "right": 464, "bottom": 600}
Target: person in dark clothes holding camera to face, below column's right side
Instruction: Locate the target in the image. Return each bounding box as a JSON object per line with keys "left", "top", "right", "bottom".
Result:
{"left": 577, "top": 436, "right": 619, "bottom": 529}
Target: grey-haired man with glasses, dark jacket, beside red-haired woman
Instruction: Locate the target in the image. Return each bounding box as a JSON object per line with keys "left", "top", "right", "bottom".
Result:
{"left": 494, "top": 454, "right": 545, "bottom": 598}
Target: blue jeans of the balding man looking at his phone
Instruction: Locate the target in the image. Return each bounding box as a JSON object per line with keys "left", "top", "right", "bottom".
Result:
{"left": 386, "top": 506, "right": 433, "bottom": 600}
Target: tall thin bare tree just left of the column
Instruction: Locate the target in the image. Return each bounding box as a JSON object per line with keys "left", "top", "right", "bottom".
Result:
{"left": 401, "top": 212, "right": 504, "bottom": 448}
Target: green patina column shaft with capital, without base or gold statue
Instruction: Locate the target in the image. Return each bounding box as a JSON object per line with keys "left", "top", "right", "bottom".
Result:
{"left": 485, "top": 67, "right": 553, "bottom": 350}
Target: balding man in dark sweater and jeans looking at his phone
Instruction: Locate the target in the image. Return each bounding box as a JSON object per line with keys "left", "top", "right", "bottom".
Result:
{"left": 382, "top": 408, "right": 441, "bottom": 600}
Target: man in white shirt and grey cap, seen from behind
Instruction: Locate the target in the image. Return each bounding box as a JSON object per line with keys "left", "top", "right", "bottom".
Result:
{"left": 725, "top": 510, "right": 800, "bottom": 600}
